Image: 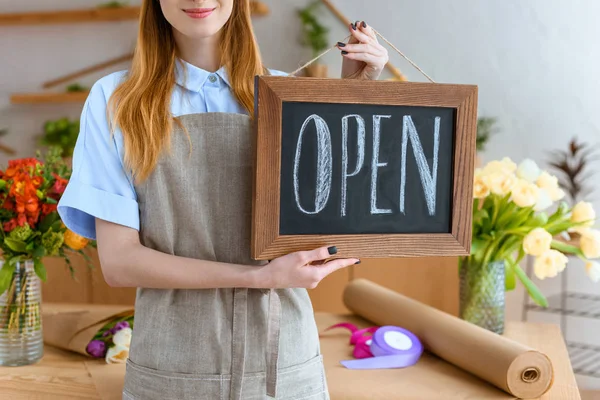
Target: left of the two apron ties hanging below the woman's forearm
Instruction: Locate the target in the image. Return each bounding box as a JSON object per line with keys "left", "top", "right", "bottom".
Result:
{"left": 229, "top": 288, "right": 248, "bottom": 400}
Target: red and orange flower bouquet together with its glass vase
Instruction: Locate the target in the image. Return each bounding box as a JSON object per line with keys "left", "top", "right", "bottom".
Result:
{"left": 0, "top": 148, "right": 94, "bottom": 365}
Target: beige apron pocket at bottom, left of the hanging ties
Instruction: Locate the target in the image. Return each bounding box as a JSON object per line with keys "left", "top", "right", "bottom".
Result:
{"left": 123, "top": 359, "right": 224, "bottom": 400}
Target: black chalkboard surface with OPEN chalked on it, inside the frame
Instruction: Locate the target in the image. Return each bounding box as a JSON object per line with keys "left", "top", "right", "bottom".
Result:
{"left": 279, "top": 102, "right": 455, "bottom": 235}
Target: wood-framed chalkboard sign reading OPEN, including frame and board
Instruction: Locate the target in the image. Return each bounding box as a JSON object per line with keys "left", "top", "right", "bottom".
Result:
{"left": 252, "top": 76, "right": 477, "bottom": 259}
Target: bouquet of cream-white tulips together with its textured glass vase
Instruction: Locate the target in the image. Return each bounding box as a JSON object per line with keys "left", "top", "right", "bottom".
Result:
{"left": 460, "top": 158, "right": 600, "bottom": 333}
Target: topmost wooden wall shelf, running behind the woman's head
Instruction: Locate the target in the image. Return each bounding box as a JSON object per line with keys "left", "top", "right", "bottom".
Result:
{"left": 0, "top": 1, "right": 269, "bottom": 26}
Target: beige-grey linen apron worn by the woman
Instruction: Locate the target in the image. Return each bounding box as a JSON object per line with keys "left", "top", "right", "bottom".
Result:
{"left": 123, "top": 113, "right": 329, "bottom": 400}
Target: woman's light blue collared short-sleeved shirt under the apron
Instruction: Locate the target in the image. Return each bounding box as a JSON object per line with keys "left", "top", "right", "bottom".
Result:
{"left": 58, "top": 62, "right": 287, "bottom": 239}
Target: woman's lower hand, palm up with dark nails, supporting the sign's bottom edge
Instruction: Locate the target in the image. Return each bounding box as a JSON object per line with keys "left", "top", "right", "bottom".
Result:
{"left": 258, "top": 246, "right": 360, "bottom": 289}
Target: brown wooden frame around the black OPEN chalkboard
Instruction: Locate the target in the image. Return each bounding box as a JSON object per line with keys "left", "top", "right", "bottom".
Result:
{"left": 251, "top": 76, "right": 478, "bottom": 260}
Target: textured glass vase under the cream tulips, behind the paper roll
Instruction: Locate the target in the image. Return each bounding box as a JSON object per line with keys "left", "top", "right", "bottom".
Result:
{"left": 460, "top": 257, "right": 505, "bottom": 334}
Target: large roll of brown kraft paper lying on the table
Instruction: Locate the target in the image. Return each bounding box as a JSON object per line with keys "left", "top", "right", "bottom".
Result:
{"left": 344, "top": 279, "right": 554, "bottom": 399}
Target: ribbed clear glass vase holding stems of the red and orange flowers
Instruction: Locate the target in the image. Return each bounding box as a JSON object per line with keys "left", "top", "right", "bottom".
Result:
{"left": 0, "top": 260, "right": 44, "bottom": 366}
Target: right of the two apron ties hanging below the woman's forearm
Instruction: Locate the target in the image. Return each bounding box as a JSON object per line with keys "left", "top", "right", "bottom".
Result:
{"left": 266, "top": 289, "right": 281, "bottom": 397}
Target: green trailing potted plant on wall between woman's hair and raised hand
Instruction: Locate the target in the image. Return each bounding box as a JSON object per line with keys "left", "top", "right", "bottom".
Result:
{"left": 298, "top": 0, "right": 329, "bottom": 78}
